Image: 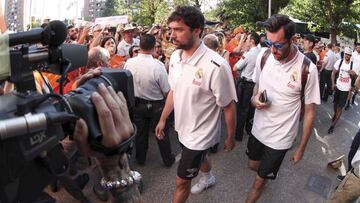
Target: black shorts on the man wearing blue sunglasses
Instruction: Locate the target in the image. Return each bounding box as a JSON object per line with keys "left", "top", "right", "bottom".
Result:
{"left": 246, "top": 136, "right": 288, "bottom": 179}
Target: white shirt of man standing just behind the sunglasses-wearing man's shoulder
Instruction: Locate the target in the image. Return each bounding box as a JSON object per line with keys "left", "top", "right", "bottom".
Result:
{"left": 235, "top": 47, "right": 261, "bottom": 80}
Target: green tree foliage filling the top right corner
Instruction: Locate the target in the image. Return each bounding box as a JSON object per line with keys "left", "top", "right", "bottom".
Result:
{"left": 281, "top": 0, "right": 360, "bottom": 43}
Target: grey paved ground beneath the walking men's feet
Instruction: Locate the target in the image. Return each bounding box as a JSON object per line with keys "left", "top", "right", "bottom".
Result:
{"left": 50, "top": 94, "right": 360, "bottom": 203}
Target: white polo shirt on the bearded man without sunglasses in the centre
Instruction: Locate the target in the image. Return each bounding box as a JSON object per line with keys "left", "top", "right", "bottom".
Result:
{"left": 169, "top": 43, "right": 237, "bottom": 150}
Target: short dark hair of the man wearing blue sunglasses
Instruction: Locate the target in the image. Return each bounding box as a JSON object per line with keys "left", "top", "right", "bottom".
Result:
{"left": 257, "top": 14, "right": 295, "bottom": 40}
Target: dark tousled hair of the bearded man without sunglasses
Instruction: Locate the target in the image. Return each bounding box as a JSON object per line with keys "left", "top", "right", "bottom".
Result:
{"left": 167, "top": 6, "right": 205, "bottom": 37}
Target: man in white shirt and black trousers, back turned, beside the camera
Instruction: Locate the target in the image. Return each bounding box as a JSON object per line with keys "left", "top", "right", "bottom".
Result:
{"left": 124, "top": 34, "right": 175, "bottom": 167}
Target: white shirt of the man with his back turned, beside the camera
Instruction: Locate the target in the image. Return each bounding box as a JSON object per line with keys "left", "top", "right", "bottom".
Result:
{"left": 124, "top": 53, "right": 170, "bottom": 101}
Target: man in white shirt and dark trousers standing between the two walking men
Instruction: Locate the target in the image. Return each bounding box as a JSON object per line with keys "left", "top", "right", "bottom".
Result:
{"left": 234, "top": 32, "right": 260, "bottom": 141}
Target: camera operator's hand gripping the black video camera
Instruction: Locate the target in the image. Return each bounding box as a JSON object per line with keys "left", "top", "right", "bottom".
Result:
{"left": 74, "top": 84, "right": 134, "bottom": 159}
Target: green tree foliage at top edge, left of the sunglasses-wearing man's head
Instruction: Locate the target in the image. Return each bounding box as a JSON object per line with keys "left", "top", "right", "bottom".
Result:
{"left": 217, "top": 0, "right": 289, "bottom": 29}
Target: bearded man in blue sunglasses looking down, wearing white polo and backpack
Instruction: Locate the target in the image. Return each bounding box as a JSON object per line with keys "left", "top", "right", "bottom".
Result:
{"left": 246, "top": 14, "right": 320, "bottom": 203}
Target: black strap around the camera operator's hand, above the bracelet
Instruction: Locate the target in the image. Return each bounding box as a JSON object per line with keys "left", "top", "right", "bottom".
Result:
{"left": 90, "top": 124, "right": 137, "bottom": 156}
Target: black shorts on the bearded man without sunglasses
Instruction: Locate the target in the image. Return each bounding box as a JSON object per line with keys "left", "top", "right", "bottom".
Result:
{"left": 177, "top": 145, "right": 209, "bottom": 180}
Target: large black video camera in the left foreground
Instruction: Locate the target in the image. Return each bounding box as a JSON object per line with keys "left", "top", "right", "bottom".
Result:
{"left": 0, "top": 22, "right": 135, "bottom": 202}
